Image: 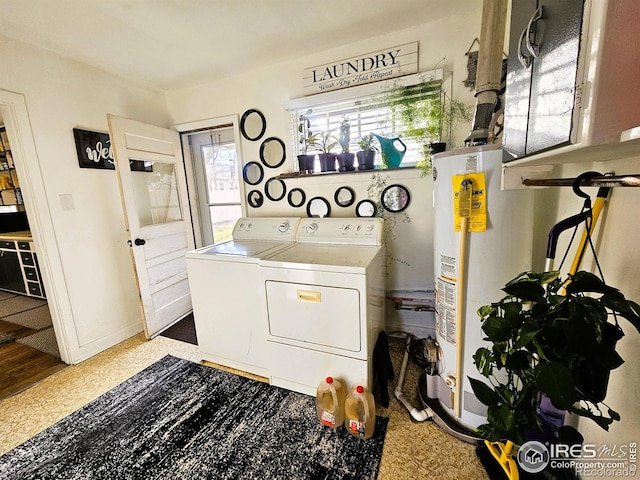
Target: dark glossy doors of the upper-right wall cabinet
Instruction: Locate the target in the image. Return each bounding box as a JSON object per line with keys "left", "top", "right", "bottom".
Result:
{"left": 503, "top": 0, "right": 583, "bottom": 157}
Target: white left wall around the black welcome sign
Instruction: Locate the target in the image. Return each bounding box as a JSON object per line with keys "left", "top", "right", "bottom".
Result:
{"left": 0, "top": 33, "right": 169, "bottom": 363}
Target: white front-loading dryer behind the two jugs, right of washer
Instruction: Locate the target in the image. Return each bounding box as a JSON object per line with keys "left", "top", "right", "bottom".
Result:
{"left": 260, "top": 218, "right": 385, "bottom": 395}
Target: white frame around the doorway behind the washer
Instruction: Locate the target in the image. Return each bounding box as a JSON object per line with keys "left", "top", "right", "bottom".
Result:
{"left": 174, "top": 115, "right": 247, "bottom": 248}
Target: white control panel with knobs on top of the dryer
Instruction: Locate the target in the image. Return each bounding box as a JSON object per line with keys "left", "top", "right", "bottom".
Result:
{"left": 298, "top": 217, "right": 384, "bottom": 246}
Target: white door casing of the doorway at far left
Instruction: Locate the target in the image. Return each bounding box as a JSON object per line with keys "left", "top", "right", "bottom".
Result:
{"left": 0, "top": 89, "right": 73, "bottom": 364}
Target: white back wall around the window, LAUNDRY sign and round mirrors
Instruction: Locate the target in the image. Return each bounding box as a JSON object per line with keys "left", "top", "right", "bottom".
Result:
{"left": 167, "top": 0, "right": 482, "bottom": 328}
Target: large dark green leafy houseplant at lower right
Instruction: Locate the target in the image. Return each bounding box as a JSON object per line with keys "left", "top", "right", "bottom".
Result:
{"left": 470, "top": 271, "right": 640, "bottom": 445}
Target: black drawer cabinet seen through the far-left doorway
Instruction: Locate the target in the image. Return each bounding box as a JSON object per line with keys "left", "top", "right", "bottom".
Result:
{"left": 0, "top": 240, "right": 46, "bottom": 298}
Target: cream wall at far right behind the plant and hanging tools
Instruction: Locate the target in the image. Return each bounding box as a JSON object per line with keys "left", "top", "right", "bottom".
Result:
{"left": 534, "top": 156, "right": 640, "bottom": 476}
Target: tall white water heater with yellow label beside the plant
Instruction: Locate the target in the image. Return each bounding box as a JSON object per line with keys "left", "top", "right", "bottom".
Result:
{"left": 427, "top": 145, "right": 533, "bottom": 429}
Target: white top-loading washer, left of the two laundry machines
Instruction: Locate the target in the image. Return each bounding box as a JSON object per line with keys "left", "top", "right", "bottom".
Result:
{"left": 186, "top": 217, "right": 300, "bottom": 376}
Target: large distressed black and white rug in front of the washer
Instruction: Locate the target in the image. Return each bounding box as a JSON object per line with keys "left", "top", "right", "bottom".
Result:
{"left": 0, "top": 356, "right": 388, "bottom": 480}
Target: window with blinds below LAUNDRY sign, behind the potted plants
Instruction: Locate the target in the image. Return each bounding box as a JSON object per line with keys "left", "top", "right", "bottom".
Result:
{"left": 286, "top": 70, "right": 443, "bottom": 171}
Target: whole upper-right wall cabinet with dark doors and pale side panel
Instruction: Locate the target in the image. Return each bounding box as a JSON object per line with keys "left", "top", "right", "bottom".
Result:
{"left": 503, "top": 0, "right": 640, "bottom": 163}
